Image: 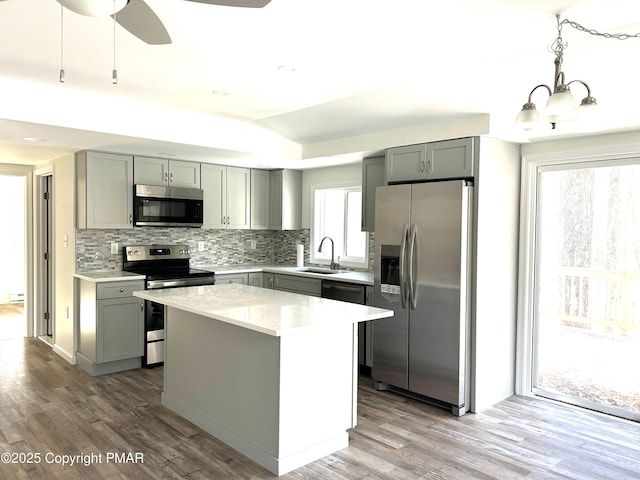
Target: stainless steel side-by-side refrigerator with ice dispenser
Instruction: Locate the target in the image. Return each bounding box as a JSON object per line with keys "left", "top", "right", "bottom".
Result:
{"left": 371, "top": 180, "right": 473, "bottom": 415}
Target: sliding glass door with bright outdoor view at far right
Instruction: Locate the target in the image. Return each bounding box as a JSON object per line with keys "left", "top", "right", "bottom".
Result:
{"left": 531, "top": 159, "right": 640, "bottom": 420}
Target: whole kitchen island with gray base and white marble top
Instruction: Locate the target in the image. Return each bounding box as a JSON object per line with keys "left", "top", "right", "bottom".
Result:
{"left": 134, "top": 284, "right": 393, "bottom": 475}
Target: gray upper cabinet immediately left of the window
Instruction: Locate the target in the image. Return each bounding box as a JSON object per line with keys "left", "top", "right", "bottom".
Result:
{"left": 269, "top": 169, "right": 302, "bottom": 230}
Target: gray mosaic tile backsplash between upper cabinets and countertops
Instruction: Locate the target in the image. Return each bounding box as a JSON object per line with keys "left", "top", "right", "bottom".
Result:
{"left": 76, "top": 227, "right": 374, "bottom": 272}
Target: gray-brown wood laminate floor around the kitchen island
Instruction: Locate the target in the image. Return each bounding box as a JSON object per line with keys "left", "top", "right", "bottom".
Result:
{"left": 0, "top": 339, "right": 640, "bottom": 480}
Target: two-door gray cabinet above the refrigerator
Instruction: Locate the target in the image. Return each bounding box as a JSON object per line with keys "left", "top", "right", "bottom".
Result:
{"left": 386, "top": 137, "right": 475, "bottom": 183}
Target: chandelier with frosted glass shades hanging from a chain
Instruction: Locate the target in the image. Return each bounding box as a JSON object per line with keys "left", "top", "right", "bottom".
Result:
{"left": 516, "top": 15, "right": 640, "bottom": 130}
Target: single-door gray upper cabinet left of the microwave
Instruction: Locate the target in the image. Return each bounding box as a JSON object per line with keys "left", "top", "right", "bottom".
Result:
{"left": 76, "top": 151, "right": 133, "bottom": 228}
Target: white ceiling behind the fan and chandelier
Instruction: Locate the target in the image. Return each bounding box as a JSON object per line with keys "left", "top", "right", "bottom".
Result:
{"left": 0, "top": 0, "right": 640, "bottom": 168}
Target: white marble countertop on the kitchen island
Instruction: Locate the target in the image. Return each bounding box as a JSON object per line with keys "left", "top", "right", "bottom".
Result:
{"left": 133, "top": 284, "right": 393, "bottom": 337}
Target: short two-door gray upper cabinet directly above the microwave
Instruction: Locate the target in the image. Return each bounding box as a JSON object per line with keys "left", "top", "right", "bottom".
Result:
{"left": 134, "top": 157, "right": 200, "bottom": 188}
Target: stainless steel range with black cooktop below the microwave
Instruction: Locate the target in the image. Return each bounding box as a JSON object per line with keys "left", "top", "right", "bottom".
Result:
{"left": 123, "top": 245, "right": 215, "bottom": 367}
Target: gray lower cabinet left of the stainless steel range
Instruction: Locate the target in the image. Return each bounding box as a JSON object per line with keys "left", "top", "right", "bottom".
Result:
{"left": 76, "top": 280, "right": 144, "bottom": 375}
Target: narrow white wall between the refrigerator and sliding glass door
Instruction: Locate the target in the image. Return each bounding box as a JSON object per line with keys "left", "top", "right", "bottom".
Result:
{"left": 471, "top": 137, "right": 520, "bottom": 412}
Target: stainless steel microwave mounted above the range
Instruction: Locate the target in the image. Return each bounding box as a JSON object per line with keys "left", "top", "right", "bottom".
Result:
{"left": 133, "top": 185, "right": 203, "bottom": 227}
